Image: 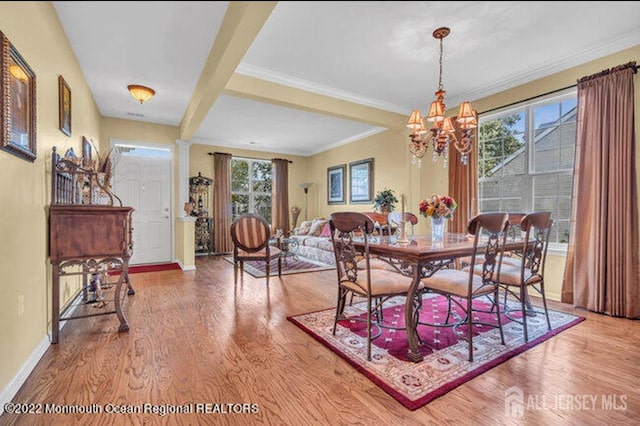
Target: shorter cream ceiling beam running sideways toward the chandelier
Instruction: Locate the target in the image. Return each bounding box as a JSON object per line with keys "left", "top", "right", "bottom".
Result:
{"left": 224, "top": 73, "right": 407, "bottom": 128}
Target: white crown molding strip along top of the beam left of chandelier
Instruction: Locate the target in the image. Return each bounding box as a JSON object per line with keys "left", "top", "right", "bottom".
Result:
{"left": 236, "top": 63, "right": 407, "bottom": 114}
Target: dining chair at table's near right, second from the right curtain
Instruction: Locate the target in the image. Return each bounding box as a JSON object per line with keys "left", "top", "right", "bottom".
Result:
{"left": 422, "top": 213, "right": 509, "bottom": 362}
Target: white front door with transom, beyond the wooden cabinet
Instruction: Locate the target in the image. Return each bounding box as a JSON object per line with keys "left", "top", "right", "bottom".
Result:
{"left": 113, "top": 144, "right": 172, "bottom": 265}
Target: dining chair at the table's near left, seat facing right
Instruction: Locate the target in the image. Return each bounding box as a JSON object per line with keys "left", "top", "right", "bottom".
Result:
{"left": 329, "top": 212, "right": 422, "bottom": 361}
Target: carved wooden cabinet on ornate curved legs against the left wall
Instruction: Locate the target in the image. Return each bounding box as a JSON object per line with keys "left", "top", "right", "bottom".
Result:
{"left": 49, "top": 147, "right": 135, "bottom": 344}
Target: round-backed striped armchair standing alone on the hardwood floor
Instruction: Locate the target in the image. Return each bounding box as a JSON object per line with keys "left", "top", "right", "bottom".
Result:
{"left": 231, "top": 213, "right": 282, "bottom": 285}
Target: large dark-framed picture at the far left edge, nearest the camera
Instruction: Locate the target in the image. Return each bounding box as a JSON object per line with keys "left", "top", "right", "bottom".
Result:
{"left": 0, "top": 32, "right": 36, "bottom": 161}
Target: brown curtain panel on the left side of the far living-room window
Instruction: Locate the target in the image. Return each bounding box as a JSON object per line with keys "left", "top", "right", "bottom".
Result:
{"left": 213, "top": 152, "right": 233, "bottom": 253}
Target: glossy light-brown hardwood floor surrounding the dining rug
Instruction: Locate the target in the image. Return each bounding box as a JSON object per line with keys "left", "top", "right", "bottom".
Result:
{"left": 0, "top": 257, "right": 640, "bottom": 425}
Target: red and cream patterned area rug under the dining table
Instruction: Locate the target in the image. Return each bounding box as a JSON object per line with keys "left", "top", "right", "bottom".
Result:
{"left": 287, "top": 294, "right": 584, "bottom": 410}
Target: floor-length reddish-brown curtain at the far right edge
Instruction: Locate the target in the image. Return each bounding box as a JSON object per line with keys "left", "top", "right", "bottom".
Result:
{"left": 562, "top": 63, "right": 640, "bottom": 318}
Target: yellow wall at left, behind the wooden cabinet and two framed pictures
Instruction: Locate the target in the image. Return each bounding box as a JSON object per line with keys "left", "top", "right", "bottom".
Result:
{"left": 0, "top": 2, "right": 100, "bottom": 389}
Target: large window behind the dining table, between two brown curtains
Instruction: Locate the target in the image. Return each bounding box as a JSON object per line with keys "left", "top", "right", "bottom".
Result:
{"left": 478, "top": 90, "right": 577, "bottom": 243}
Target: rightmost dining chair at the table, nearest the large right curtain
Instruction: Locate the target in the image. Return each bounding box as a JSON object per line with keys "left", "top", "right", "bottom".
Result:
{"left": 498, "top": 212, "right": 553, "bottom": 342}
